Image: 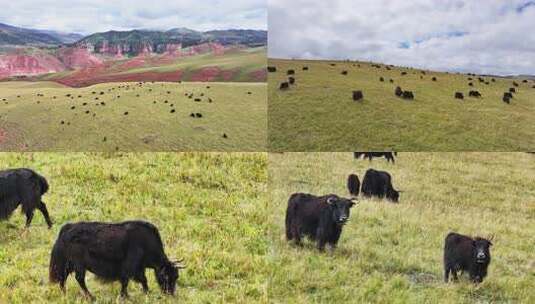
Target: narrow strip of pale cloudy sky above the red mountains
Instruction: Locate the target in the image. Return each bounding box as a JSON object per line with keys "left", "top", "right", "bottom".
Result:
{"left": 0, "top": 0, "right": 267, "bottom": 34}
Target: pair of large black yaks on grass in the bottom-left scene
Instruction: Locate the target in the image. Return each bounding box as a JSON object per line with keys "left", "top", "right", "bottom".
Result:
{"left": 0, "top": 168, "right": 184, "bottom": 299}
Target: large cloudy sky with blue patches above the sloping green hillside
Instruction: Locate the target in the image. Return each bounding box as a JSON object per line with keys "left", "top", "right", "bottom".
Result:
{"left": 268, "top": 0, "right": 535, "bottom": 75}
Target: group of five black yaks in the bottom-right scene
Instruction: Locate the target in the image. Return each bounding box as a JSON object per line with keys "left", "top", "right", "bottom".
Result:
{"left": 285, "top": 152, "right": 492, "bottom": 283}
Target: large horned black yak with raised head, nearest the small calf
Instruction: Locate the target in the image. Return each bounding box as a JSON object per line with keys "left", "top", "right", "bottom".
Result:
{"left": 286, "top": 193, "right": 355, "bottom": 251}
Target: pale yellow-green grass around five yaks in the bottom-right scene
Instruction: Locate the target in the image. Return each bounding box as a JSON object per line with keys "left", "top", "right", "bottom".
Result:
{"left": 268, "top": 153, "right": 535, "bottom": 303}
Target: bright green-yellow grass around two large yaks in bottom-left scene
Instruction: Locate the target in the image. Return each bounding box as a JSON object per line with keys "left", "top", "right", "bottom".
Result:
{"left": 0, "top": 153, "right": 269, "bottom": 303}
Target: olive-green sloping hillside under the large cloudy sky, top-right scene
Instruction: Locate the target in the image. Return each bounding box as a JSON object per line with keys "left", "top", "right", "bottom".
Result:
{"left": 268, "top": 59, "right": 535, "bottom": 151}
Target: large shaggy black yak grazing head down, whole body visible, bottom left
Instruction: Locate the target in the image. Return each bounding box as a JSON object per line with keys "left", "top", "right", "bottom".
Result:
{"left": 49, "top": 221, "right": 183, "bottom": 298}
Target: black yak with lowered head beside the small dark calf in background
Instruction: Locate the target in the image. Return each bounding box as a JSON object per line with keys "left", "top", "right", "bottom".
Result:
{"left": 361, "top": 169, "right": 401, "bottom": 203}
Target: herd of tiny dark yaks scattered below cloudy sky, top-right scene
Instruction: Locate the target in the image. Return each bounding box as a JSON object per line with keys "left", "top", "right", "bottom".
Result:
{"left": 267, "top": 63, "right": 535, "bottom": 104}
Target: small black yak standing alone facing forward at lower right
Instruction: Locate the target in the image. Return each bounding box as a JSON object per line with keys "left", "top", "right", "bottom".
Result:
{"left": 444, "top": 232, "right": 492, "bottom": 283}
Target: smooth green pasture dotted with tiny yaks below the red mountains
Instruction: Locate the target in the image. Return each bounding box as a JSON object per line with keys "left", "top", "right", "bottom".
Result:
{"left": 0, "top": 82, "right": 267, "bottom": 151}
